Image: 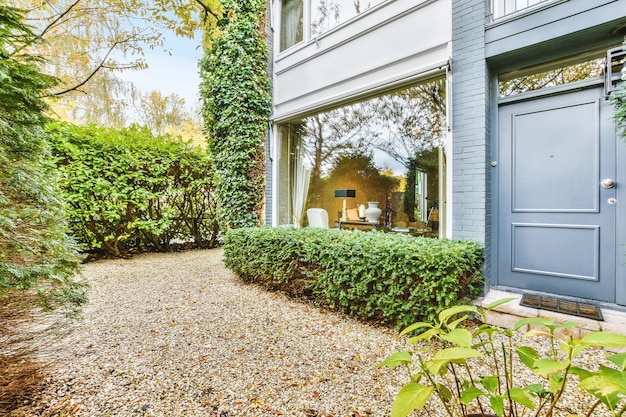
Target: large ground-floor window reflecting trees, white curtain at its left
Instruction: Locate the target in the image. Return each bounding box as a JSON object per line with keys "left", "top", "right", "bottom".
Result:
{"left": 277, "top": 78, "right": 446, "bottom": 235}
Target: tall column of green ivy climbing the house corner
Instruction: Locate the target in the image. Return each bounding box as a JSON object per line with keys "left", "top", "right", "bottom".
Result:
{"left": 200, "top": 0, "right": 271, "bottom": 228}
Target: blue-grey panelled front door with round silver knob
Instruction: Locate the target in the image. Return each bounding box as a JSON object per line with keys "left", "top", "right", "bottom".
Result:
{"left": 494, "top": 87, "right": 626, "bottom": 304}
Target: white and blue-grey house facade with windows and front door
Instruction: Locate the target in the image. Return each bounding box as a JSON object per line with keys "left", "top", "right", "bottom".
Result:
{"left": 266, "top": 0, "right": 626, "bottom": 318}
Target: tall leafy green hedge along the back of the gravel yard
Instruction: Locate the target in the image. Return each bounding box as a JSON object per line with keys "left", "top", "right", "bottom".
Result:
{"left": 49, "top": 123, "right": 218, "bottom": 256}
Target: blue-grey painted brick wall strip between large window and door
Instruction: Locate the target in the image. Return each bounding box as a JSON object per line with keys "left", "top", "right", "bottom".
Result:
{"left": 452, "top": 0, "right": 490, "bottom": 244}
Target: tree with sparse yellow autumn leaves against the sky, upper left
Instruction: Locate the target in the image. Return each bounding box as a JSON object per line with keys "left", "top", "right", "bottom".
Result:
{"left": 12, "top": 0, "right": 222, "bottom": 128}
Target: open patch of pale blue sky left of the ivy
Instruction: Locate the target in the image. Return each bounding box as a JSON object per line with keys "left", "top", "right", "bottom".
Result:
{"left": 118, "top": 34, "right": 202, "bottom": 110}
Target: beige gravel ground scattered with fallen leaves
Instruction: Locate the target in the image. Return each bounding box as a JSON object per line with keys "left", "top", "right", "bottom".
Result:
{"left": 8, "top": 249, "right": 616, "bottom": 417}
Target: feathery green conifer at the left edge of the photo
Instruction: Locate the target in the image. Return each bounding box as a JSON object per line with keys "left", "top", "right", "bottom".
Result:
{"left": 0, "top": 3, "right": 84, "bottom": 306}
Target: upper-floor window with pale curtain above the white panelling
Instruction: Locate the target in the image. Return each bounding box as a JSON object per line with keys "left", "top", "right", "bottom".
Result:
{"left": 280, "top": 0, "right": 385, "bottom": 51}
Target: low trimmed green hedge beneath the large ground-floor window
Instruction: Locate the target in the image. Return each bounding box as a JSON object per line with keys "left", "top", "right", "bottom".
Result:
{"left": 223, "top": 228, "right": 484, "bottom": 326}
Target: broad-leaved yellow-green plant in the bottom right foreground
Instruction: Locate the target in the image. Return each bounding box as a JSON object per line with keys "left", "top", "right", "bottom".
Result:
{"left": 378, "top": 299, "right": 626, "bottom": 417}
